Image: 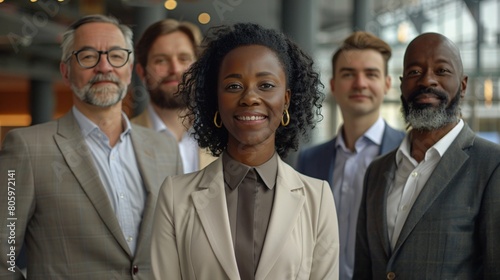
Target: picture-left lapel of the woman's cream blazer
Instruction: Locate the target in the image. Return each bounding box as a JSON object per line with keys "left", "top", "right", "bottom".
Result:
{"left": 192, "top": 157, "right": 240, "bottom": 279}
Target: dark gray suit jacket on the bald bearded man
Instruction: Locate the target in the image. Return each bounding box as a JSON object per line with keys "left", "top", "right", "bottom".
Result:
{"left": 354, "top": 125, "right": 500, "bottom": 280}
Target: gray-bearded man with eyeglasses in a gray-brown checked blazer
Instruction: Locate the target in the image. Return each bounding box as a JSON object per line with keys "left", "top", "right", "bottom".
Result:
{"left": 0, "top": 15, "right": 183, "bottom": 280}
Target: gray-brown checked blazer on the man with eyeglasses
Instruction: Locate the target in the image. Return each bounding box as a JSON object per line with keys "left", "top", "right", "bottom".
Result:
{"left": 0, "top": 112, "right": 182, "bottom": 280}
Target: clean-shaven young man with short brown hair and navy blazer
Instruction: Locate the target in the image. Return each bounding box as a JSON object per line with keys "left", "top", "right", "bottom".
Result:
{"left": 297, "top": 31, "right": 404, "bottom": 280}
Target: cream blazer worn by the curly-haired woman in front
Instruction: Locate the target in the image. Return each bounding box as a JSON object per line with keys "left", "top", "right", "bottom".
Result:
{"left": 151, "top": 158, "right": 339, "bottom": 280}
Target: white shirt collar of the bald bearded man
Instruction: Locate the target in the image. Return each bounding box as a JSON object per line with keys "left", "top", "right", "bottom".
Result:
{"left": 396, "top": 119, "right": 464, "bottom": 163}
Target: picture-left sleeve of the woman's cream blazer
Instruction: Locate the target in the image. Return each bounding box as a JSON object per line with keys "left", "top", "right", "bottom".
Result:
{"left": 151, "top": 177, "right": 182, "bottom": 280}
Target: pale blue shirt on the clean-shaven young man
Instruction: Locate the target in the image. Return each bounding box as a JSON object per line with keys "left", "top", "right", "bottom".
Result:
{"left": 330, "top": 118, "right": 386, "bottom": 280}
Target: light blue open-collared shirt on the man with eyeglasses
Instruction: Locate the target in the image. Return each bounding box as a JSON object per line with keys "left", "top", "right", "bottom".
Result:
{"left": 72, "top": 106, "right": 146, "bottom": 254}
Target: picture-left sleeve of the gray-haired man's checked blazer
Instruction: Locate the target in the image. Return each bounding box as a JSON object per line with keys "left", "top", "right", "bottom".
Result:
{"left": 0, "top": 131, "right": 35, "bottom": 279}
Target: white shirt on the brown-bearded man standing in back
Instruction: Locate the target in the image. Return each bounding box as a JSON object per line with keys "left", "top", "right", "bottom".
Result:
{"left": 147, "top": 103, "right": 200, "bottom": 173}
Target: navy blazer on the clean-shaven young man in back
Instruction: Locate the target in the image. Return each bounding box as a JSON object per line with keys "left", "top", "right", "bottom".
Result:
{"left": 296, "top": 123, "right": 405, "bottom": 184}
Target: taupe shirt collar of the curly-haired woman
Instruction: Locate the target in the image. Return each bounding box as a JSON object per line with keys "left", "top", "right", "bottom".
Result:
{"left": 222, "top": 153, "right": 278, "bottom": 190}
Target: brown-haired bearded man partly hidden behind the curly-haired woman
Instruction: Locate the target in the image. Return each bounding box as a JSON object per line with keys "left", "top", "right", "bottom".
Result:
{"left": 132, "top": 19, "right": 213, "bottom": 173}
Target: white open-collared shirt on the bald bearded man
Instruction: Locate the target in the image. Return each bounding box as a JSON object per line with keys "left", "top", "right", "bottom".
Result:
{"left": 386, "top": 120, "right": 464, "bottom": 249}
